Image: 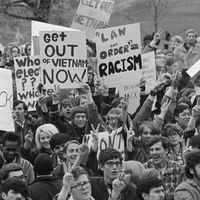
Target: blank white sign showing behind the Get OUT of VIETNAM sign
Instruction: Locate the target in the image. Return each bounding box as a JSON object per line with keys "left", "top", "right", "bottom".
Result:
{"left": 31, "top": 20, "right": 79, "bottom": 55}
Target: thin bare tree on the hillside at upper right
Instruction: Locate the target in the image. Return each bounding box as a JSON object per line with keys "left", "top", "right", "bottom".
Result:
{"left": 144, "top": 0, "right": 179, "bottom": 32}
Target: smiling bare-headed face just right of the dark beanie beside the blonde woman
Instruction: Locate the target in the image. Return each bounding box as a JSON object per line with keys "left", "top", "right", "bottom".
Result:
{"left": 66, "top": 143, "right": 79, "bottom": 164}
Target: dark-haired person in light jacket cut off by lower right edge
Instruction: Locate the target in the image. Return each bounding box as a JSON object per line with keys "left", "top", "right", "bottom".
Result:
{"left": 174, "top": 150, "right": 200, "bottom": 200}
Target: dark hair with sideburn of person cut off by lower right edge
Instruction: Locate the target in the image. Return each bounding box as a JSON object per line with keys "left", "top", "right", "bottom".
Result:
{"left": 185, "top": 150, "right": 200, "bottom": 179}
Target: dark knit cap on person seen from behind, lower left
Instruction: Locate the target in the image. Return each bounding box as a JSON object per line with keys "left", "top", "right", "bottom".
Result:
{"left": 34, "top": 153, "right": 53, "bottom": 175}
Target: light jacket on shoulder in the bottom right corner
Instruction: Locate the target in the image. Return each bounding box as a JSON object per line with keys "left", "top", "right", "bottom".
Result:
{"left": 174, "top": 179, "right": 200, "bottom": 200}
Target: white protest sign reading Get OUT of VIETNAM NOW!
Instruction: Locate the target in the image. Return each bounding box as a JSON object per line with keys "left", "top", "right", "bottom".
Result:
{"left": 40, "top": 31, "right": 87, "bottom": 89}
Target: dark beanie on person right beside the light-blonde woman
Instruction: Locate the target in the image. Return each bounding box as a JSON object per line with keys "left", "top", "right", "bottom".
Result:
{"left": 49, "top": 133, "right": 70, "bottom": 150}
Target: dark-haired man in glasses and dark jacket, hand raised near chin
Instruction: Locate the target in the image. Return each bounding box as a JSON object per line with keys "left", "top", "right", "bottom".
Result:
{"left": 90, "top": 148, "right": 136, "bottom": 200}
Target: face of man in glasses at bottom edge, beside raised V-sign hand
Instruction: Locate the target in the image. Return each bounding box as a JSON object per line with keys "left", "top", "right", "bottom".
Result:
{"left": 71, "top": 174, "right": 91, "bottom": 200}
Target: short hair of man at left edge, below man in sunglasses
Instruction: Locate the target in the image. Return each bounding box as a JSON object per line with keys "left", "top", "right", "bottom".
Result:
{"left": 0, "top": 163, "right": 22, "bottom": 181}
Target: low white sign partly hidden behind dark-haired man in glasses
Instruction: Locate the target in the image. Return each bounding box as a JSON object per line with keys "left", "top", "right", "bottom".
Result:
{"left": 84, "top": 127, "right": 124, "bottom": 157}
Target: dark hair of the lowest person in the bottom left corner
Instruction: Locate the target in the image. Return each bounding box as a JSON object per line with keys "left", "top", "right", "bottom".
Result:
{"left": 2, "top": 178, "right": 29, "bottom": 199}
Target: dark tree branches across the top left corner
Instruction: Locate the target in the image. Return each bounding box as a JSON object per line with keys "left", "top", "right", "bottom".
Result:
{"left": 0, "top": 0, "right": 77, "bottom": 22}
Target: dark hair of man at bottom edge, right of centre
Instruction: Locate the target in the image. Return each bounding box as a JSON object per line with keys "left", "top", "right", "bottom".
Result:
{"left": 137, "top": 177, "right": 163, "bottom": 200}
